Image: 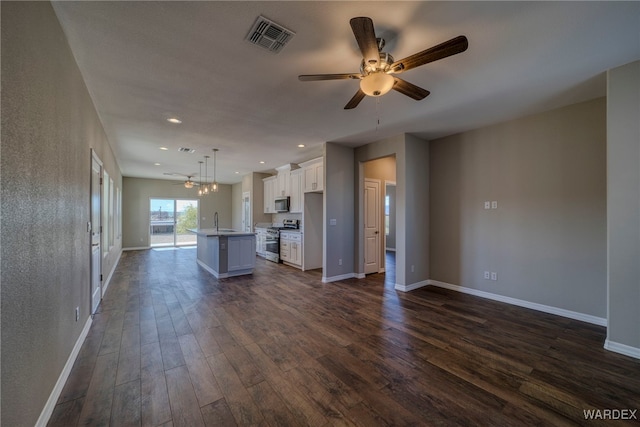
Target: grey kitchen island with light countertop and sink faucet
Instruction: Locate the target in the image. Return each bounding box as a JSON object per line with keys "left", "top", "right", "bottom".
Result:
{"left": 189, "top": 228, "right": 256, "bottom": 279}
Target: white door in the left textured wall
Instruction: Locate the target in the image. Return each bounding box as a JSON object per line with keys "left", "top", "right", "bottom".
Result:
{"left": 89, "top": 154, "right": 102, "bottom": 314}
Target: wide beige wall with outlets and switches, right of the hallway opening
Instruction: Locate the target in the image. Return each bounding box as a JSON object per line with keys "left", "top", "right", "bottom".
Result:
{"left": 430, "top": 98, "right": 606, "bottom": 318}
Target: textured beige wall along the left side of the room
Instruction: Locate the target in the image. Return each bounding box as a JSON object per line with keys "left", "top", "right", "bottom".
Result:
{"left": 0, "top": 2, "right": 121, "bottom": 427}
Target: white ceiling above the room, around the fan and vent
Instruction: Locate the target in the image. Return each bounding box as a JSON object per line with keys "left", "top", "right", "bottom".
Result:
{"left": 54, "top": 1, "right": 640, "bottom": 183}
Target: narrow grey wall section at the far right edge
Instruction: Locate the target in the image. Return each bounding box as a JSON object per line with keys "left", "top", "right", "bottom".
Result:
{"left": 607, "top": 61, "right": 640, "bottom": 358}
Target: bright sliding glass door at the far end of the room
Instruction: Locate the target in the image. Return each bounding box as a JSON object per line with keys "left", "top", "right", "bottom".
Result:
{"left": 149, "top": 198, "right": 200, "bottom": 247}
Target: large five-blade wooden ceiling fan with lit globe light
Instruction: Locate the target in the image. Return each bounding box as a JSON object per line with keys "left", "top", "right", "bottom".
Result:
{"left": 298, "top": 17, "right": 469, "bottom": 110}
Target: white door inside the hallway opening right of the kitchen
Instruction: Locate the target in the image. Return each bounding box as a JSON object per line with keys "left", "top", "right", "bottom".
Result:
{"left": 364, "top": 178, "right": 380, "bottom": 274}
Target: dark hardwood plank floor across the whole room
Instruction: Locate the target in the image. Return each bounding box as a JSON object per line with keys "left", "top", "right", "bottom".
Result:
{"left": 49, "top": 249, "right": 640, "bottom": 427}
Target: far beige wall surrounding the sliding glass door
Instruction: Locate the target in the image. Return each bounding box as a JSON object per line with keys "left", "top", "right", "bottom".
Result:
{"left": 122, "top": 177, "right": 232, "bottom": 249}
